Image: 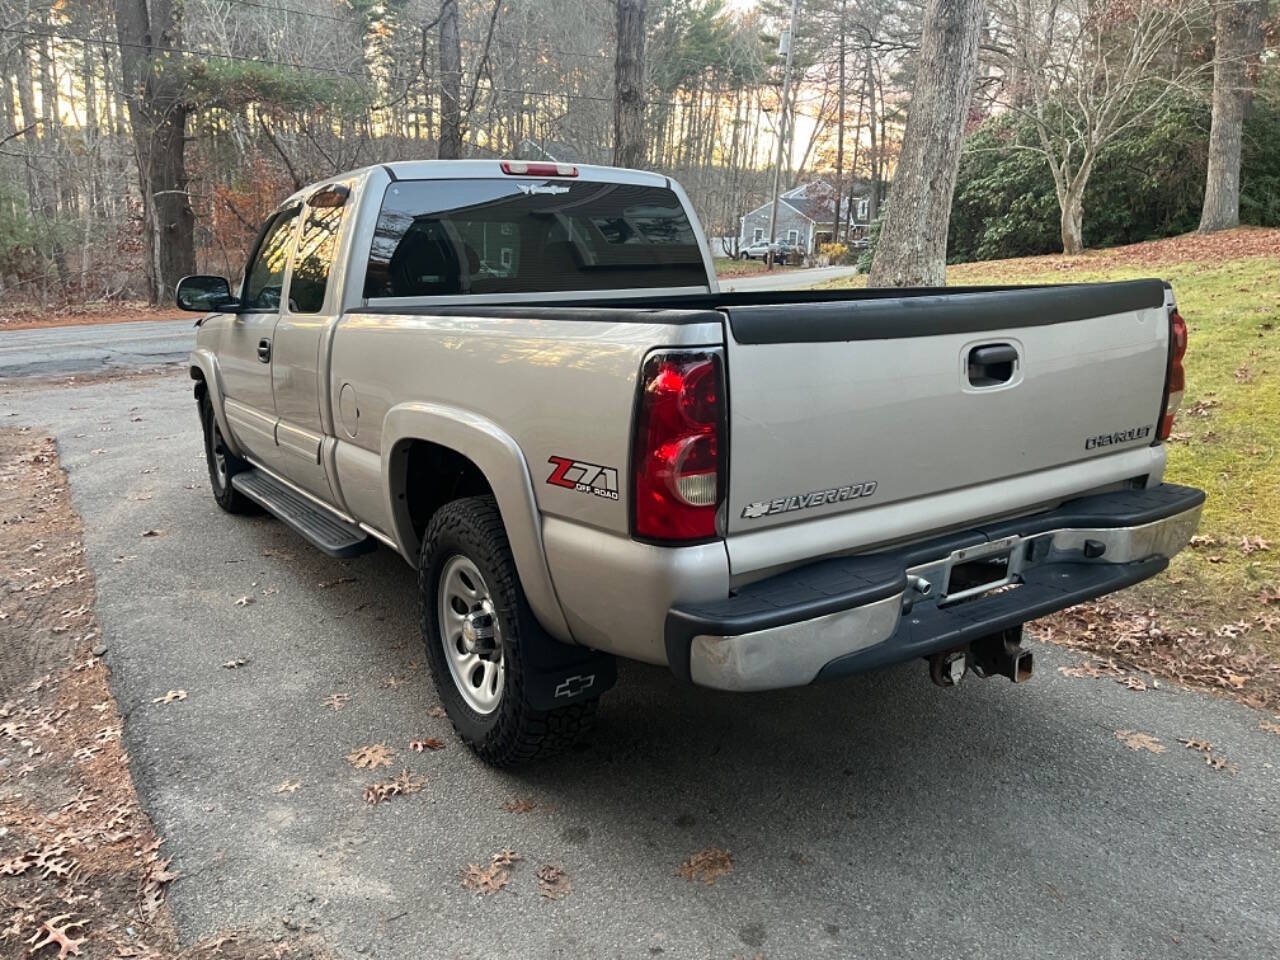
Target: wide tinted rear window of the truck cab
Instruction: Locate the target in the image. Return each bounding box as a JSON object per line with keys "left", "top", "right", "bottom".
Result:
{"left": 365, "top": 178, "right": 707, "bottom": 298}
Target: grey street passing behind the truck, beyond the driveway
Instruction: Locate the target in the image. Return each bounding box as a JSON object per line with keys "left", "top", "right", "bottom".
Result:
{"left": 0, "top": 266, "right": 854, "bottom": 380}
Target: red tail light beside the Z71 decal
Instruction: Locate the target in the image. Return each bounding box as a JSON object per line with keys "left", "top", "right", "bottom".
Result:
{"left": 631, "top": 353, "right": 726, "bottom": 541}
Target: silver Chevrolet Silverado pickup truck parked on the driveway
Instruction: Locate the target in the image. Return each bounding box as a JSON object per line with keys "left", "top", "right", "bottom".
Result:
{"left": 178, "top": 161, "right": 1203, "bottom": 764}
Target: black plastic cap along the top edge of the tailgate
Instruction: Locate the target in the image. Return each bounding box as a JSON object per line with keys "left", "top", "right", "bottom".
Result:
{"left": 723, "top": 279, "right": 1165, "bottom": 343}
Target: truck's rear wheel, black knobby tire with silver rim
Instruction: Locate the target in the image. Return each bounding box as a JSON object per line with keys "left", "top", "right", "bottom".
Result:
{"left": 419, "top": 497, "right": 596, "bottom": 767}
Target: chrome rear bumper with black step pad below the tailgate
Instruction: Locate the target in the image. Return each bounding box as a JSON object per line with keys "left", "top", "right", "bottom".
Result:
{"left": 664, "top": 484, "right": 1204, "bottom": 690}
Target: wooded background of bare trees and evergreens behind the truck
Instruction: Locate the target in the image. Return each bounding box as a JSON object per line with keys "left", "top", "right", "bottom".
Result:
{"left": 0, "top": 0, "right": 1280, "bottom": 306}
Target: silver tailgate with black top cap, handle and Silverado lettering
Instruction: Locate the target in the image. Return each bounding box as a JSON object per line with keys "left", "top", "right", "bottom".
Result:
{"left": 724, "top": 280, "right": 1169, "bottom": 547}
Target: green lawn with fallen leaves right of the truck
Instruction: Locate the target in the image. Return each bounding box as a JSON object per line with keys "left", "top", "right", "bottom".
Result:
{"left": 831, "top": 232, "right": 1280, "bottom": 686}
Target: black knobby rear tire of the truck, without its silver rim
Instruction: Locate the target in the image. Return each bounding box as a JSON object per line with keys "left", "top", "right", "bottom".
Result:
{"left": 417, "top": 497, "right": 596, "bottom": 767}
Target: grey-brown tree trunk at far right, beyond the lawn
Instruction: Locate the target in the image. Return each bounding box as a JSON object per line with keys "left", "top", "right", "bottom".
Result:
{"left": 1199, "top": 0, "right": 1267, "bottom": 233}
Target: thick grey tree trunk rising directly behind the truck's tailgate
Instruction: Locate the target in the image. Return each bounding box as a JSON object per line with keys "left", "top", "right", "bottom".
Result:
{"left": 869, "top": 0, "right": 984, "bottom": 287}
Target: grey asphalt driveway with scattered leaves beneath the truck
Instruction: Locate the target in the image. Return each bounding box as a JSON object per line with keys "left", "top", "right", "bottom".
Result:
{"left": 0, "top": 375, "right": 1280, "bottom": 960}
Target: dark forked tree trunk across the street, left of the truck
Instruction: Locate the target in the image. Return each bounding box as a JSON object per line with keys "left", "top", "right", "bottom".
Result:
{"left": 115, "top": 0, "right": 196, "bottom": 303}
